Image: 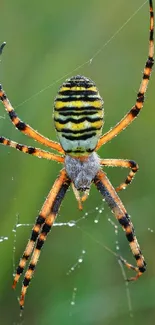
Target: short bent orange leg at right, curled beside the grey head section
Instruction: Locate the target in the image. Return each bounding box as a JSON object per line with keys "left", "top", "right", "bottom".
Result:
{"left": 100, "top": 159, "right": 139, "bottom": 192}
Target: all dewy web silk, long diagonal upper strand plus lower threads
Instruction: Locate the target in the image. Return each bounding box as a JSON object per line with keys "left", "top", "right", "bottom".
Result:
{"left": 0, "top": 1, "right": 151, "bottom": 324}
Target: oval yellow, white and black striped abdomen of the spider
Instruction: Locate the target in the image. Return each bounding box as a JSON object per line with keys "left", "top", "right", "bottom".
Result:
{"left": 54, "top": 76, "right": 103, "bottom": 156}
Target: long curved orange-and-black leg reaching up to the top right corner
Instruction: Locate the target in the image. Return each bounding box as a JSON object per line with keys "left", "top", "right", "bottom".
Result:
{"left": 96, "top": 0, "right": 154, "bottom": 150}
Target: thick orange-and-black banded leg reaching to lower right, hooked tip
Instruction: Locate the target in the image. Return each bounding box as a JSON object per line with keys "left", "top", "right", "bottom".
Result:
{"left": 94, "top": 170, "right": 146, "bottom": 281}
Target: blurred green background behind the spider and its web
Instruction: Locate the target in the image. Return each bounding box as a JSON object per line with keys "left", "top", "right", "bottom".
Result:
{"left": 0, "top": 0, "right": 155, "bottom": 325}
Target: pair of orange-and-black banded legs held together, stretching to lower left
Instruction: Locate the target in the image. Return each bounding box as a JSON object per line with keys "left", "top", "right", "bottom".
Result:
{"left": 12, "top": 169, "right": 70, "bottom": 308}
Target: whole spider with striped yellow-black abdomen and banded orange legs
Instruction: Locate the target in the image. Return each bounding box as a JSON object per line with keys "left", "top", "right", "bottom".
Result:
{"left": 0, "top": 0, "right": 154, "bottom": 309}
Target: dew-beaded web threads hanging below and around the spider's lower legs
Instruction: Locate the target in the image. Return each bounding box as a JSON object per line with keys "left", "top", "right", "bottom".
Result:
{"left": 12, "top": 199, "right": 133, "bottom": 318}
